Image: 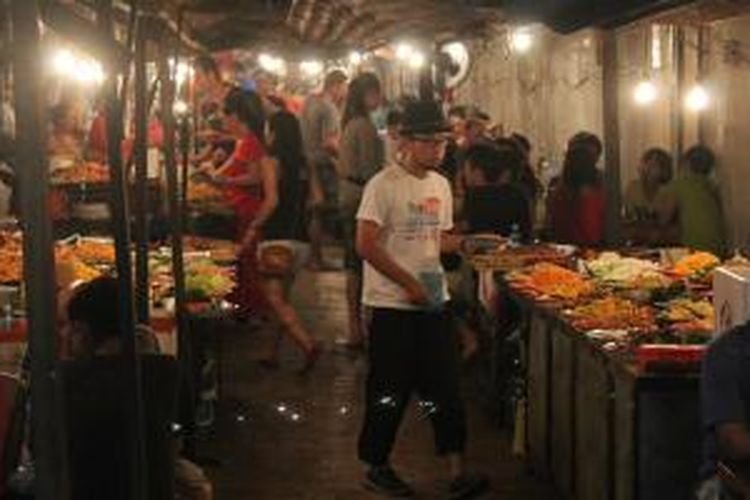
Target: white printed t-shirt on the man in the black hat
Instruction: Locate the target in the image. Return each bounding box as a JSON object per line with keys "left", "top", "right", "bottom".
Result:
{"left": 357, "top": 165, "right": 453, "bottom": 310}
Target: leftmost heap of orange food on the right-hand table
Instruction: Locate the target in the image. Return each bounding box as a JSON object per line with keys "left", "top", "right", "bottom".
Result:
{"left": 511, "top": 263, "right": 594, "bottom": 300}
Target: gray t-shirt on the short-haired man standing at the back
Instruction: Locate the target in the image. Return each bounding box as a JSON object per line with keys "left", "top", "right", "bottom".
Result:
{"left": 300, "top": 94, "right": 341, "bottom": 165}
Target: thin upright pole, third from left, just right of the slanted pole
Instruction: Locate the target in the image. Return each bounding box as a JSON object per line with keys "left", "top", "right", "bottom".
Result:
{"left": 133, "top": 18, "right": 149, "bottom": 323}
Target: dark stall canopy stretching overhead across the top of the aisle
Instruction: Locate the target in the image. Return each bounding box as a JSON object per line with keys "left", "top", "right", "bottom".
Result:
{"left": 42, "top": 0, "right": 724, "bottom": 57}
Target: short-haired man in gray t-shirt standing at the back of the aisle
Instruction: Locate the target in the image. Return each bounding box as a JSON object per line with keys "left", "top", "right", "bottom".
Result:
{"left": 300, "top": 70, "right": 348, "bottom": 267}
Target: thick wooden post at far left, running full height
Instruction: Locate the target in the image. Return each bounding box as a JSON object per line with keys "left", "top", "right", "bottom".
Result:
{"left": 11, "top": 0, "right": 69, "bottom": 500}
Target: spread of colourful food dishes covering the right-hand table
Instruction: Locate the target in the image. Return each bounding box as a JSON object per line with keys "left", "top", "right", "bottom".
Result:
{"left": 471, "top": 240, "right": 748, "bottom": 370}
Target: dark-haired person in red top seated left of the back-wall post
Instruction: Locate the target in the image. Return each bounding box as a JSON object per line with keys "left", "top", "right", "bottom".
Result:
{"left": 547, "top": 144, "right": 605, "bottom": 247}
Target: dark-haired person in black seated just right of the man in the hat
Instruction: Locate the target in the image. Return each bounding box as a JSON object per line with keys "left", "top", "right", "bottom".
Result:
{"left": 464, "top": 143, "right": 532, "bottom": 242}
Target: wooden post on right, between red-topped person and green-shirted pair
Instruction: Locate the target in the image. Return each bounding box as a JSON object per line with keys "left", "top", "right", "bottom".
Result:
{"left": 602, "top": 29, "right": 622, "bottom": 246}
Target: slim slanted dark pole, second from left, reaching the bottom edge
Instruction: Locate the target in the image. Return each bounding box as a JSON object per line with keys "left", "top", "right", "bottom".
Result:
{"left": 97, "top": 0, "right": 148, "bottom": 500}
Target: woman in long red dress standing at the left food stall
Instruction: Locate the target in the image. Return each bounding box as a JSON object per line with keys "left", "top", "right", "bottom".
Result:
{"left": 211, "top": 89, "right": 277, "bottom": 314}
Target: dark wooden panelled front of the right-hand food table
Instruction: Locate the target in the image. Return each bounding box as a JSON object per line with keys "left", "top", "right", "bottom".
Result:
{"left": 498, "top": 277, "right": 701, "bottom": 500}
